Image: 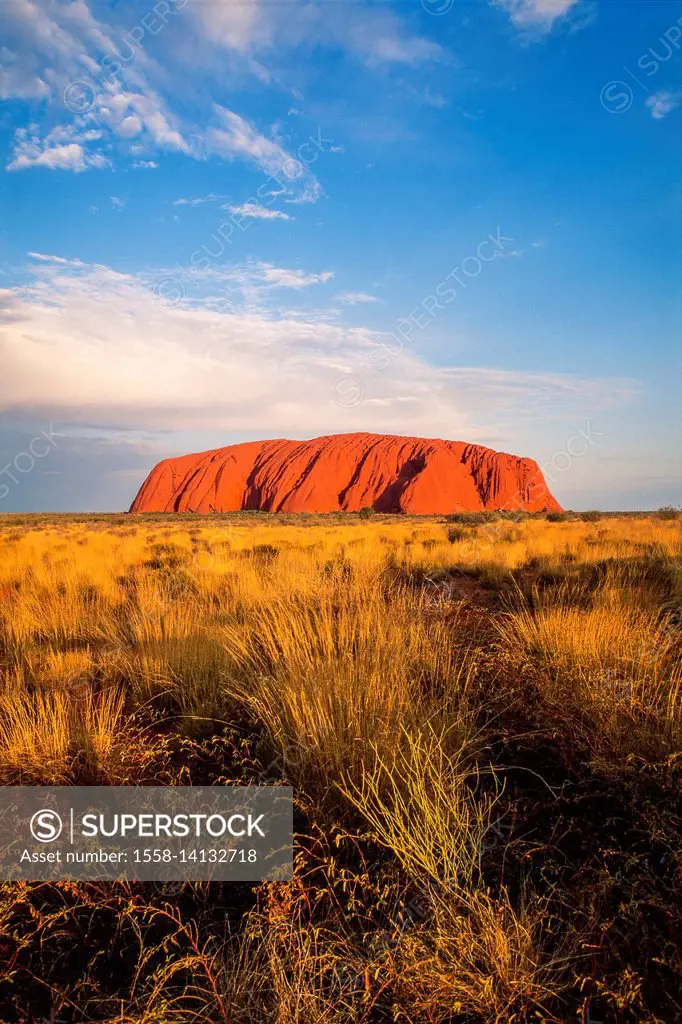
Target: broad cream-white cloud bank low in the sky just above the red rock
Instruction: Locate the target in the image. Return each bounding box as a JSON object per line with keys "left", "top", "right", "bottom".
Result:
{"left": 0, "top": 255, "right": 632, "bottom": 454}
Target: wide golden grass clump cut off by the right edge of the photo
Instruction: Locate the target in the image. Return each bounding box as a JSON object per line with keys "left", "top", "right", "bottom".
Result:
{"left": 498, "top": 580, "right": 682, "bottom": 758}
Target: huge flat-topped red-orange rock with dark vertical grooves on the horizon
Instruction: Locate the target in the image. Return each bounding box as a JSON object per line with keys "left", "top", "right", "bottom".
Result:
{"left": 130, "top": 433, "right": 561, "bottom": 514}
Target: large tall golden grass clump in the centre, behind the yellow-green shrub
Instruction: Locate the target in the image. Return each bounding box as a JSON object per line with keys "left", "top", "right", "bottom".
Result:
{"left": 223, "top": 586, "right": 469, "bottom": 797}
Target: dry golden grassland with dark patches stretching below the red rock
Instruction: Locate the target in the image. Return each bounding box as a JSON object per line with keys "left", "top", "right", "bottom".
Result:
{"left": 0, "top": 510, "right": 682, "bottom": 1024}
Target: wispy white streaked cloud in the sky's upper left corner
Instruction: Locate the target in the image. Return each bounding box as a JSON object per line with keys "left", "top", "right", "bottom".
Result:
{"left": 0, "top": 0, "right": 322, "bottom": 202}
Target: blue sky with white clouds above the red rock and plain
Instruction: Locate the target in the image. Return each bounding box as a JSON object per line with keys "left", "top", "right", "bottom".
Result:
{"left": 0, "top": 0, "right": 682, "bottom": 512}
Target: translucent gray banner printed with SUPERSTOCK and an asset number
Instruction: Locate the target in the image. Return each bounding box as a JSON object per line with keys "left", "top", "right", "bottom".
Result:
{"left": 0, "top": 785, "right": 293, "bottom": 882}
